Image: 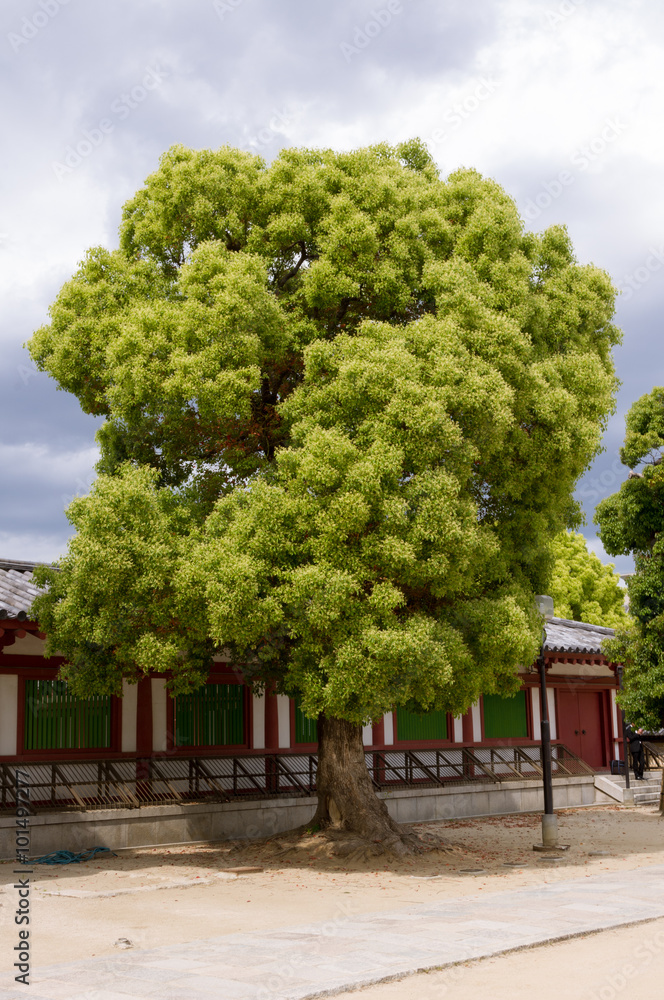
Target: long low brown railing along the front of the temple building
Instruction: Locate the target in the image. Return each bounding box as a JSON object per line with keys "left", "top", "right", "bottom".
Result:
{"left": 0, "top": 744, "right": 594, "bottom": 811}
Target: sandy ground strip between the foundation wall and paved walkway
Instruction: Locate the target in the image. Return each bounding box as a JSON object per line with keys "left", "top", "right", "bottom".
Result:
{"left": 0, "top": 806, "right": 664, "bottom": 976}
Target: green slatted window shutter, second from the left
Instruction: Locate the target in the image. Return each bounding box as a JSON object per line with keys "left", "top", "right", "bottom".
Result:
{"left": 175, "top": 684, "right": 245, "bottom": 747}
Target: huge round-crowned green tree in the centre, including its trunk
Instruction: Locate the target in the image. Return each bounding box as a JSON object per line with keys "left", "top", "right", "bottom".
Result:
{"left": 30, "top": 141, "right": 618, "bottom": 849}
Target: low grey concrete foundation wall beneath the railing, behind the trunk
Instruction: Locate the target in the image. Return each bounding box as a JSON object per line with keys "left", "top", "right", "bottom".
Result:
{"left": 0, "top": 775, "right": 614, "bottom": 858}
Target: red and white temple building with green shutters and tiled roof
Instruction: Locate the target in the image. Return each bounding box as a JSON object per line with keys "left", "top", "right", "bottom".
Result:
{"left": 0, "top": 560, "right": 622, "bottom": 846}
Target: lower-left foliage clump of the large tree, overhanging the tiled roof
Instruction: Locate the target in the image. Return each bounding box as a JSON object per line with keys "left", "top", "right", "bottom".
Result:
{"left": 33, "top": 465, "right": 213, "bottom": 697}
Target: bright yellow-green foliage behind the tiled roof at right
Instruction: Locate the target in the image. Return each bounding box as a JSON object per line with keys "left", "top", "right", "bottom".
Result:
{"left": 547, "top": 531, "right": 629, "bottom": 628}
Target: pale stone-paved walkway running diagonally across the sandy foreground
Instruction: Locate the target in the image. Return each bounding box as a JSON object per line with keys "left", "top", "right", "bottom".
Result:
{"left": 0, "top": 865, "right": 664, "bottom": 1000}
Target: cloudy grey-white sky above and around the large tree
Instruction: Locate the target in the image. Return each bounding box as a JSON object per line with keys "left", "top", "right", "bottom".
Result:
{"left": 0, "top": 0, "right": 664, "bottom": 571}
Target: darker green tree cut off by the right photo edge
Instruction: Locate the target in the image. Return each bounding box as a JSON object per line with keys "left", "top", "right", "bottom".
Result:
{"left": 595, "top": 386, "right": 664, "bottom": 729}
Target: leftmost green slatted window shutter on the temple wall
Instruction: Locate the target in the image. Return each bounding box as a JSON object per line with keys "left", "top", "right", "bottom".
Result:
{"left": 24, "top": 680, "right": 111, "bottom": 750}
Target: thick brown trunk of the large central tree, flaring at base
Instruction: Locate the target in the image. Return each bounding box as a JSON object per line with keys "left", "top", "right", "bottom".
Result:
{"left": 313, "top": 716, "right": 414, "bottom": 854}
